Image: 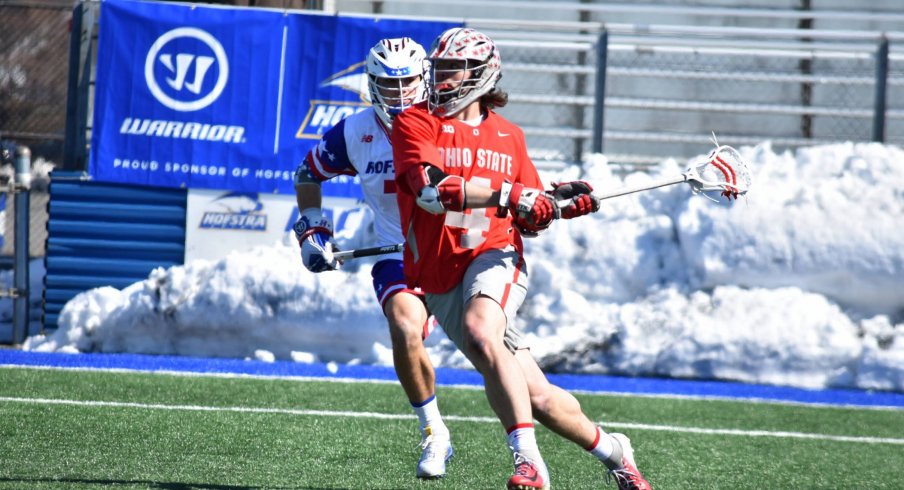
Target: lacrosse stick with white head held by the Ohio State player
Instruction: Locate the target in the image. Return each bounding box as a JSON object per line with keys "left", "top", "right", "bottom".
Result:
{"left": 556, "top": 135, "right": 752, "bottom": 208}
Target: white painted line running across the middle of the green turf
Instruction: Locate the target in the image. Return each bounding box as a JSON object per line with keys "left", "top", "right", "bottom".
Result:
{"left": 0, "top": 396, "right": 904, "bottom": 446}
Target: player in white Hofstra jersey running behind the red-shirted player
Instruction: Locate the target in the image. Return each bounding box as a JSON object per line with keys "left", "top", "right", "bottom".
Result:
{"left": 295, "top": 38, "right": 453, "bottom": 478}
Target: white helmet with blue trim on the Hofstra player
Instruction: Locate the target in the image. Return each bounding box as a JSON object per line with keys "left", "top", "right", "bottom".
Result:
{"left": 366, "top": 37, "right": 429, "bottom": 128}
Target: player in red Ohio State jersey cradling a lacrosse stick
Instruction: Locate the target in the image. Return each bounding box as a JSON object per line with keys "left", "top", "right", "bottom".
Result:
{"left": 392, "top": 28, "right": 650, "bottom": 489}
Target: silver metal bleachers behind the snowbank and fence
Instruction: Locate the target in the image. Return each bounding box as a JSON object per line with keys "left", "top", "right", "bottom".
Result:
{"left": 324, "top": 0, "right": 904, "bottom": 168}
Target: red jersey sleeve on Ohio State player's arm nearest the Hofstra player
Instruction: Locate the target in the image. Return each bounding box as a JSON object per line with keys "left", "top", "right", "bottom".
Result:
{"left": 391, "top": 109, "right": 443, "bottom": 194}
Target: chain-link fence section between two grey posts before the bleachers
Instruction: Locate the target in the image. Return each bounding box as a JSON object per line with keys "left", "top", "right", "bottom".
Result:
{"left": 605, "top": 38, "right": 888, "bottom": 162}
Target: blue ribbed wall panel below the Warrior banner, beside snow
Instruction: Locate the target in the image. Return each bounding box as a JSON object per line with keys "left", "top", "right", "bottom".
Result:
{"left": 44, "top": 172, "right": 187, "bottom": 329}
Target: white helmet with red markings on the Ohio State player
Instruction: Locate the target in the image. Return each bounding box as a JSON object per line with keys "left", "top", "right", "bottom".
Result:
{"left": 427, "top": 27, "right": 502, "bottom": 117}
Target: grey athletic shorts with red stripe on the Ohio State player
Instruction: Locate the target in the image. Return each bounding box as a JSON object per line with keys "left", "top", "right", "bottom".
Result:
{"left": 425, "top": 247, "right": 529, "bottom": 353}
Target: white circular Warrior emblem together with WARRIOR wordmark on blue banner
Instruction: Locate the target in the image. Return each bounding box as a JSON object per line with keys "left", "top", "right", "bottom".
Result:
{"left": 119, "top": 27, "right": 245, "bottom": 143}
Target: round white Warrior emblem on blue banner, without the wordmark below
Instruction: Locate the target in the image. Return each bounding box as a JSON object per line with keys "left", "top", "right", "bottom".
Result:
{"left": 144, "top": 27, "right": 229, "bottom": 112}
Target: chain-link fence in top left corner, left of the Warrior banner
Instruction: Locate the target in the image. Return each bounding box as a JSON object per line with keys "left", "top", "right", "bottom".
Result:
{"left": 0, "top": 1, "right": 72, "bottom": 162}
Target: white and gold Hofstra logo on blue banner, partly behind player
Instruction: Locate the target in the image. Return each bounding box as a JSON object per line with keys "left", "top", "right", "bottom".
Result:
{"left": 295, "top": 61, "right": 370, "bottom": 139}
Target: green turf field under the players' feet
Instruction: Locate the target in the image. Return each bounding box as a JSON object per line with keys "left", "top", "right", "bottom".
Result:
{"left": 0, "top": 367, "right": 904, "bottom": 490}
